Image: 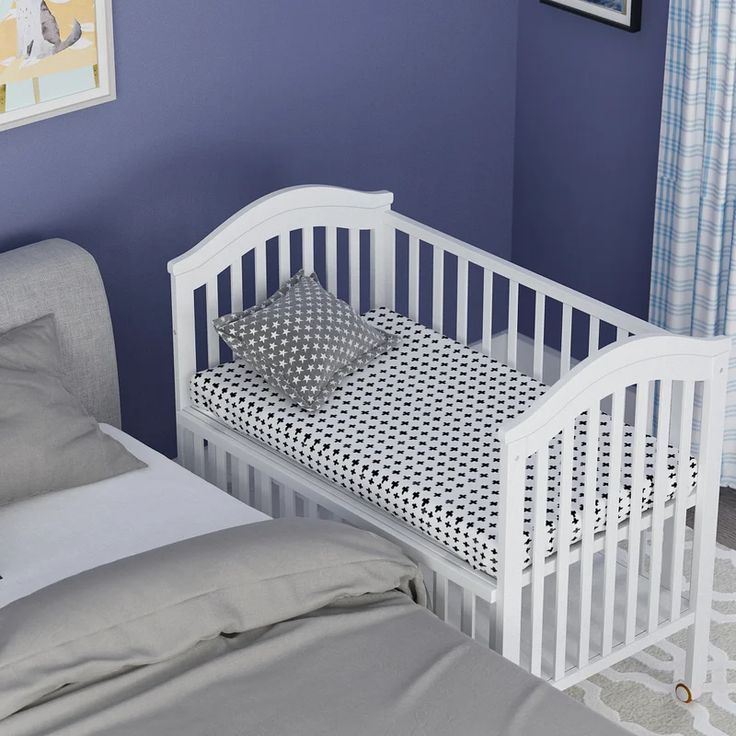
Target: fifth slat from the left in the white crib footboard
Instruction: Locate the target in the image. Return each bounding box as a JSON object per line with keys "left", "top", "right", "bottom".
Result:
{"left": 625, "top": 382, "right": 649, "bottom": 644}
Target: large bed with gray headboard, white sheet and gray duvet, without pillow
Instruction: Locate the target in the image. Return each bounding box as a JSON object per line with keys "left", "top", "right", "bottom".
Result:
{"left": 0, "top": 241, "right": 621, "bottom": 736}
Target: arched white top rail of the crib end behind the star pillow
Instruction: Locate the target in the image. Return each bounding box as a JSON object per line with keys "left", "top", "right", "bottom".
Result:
{"left": 168, "top": 184, "right": 394, "bottom": 276}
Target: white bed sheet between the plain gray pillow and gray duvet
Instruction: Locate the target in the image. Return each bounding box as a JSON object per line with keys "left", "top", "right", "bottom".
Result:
{"left": 0, "top": 424, "right": 268, "bottom": 607}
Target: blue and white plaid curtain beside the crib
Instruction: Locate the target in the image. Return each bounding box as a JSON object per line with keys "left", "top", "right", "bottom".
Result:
{"left": 649, "top": 0, "right": 736, "bottom": 487}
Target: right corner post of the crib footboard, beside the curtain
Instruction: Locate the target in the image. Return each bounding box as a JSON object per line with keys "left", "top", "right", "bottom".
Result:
{"left": 685, "top": 354, "right": 729, "bottom": 698}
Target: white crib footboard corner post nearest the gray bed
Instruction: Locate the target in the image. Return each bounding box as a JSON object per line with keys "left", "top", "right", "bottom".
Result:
{"left": 496, "top": 440, "right": 527, "bottom": 664}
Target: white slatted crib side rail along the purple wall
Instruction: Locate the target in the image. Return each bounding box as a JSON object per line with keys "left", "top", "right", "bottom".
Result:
{"left": 378, "top": 210, "right": 662, "bottom": 384}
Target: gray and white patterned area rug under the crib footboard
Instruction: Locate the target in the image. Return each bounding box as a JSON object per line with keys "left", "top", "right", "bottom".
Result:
{"left": 567, "top": 545, "right": 736, "bottom": 736}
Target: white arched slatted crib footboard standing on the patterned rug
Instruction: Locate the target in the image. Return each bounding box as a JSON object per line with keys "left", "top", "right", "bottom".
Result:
{"left": 496, "top": 335, "right": 730, "bottom": 696}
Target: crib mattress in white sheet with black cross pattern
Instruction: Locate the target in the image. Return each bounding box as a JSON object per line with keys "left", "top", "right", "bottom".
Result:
{"left": 190, "top": 308, "right": 697, "bottom": 575}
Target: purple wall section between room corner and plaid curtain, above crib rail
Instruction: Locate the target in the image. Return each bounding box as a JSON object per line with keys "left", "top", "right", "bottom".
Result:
{"left": 513, "top": 0, "right": 668, "bottom": 317}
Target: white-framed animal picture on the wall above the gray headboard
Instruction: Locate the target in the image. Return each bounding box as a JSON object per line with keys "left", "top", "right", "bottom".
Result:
{"left": 0, "top": 0, "right": 115, "bottom": 131}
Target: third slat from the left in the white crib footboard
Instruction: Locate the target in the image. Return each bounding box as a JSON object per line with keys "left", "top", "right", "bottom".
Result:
{"left": 578, "top": 402, "right": 601, "bottom": 669}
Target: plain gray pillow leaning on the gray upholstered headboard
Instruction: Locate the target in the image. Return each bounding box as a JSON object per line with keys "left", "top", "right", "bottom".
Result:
{"left": 0, "top": 314, "right": 146, "bottom": 506}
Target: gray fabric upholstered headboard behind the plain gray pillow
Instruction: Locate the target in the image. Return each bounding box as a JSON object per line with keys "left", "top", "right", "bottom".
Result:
{"left": 0, "top": 240, "right": 120, "bottom": 427}
